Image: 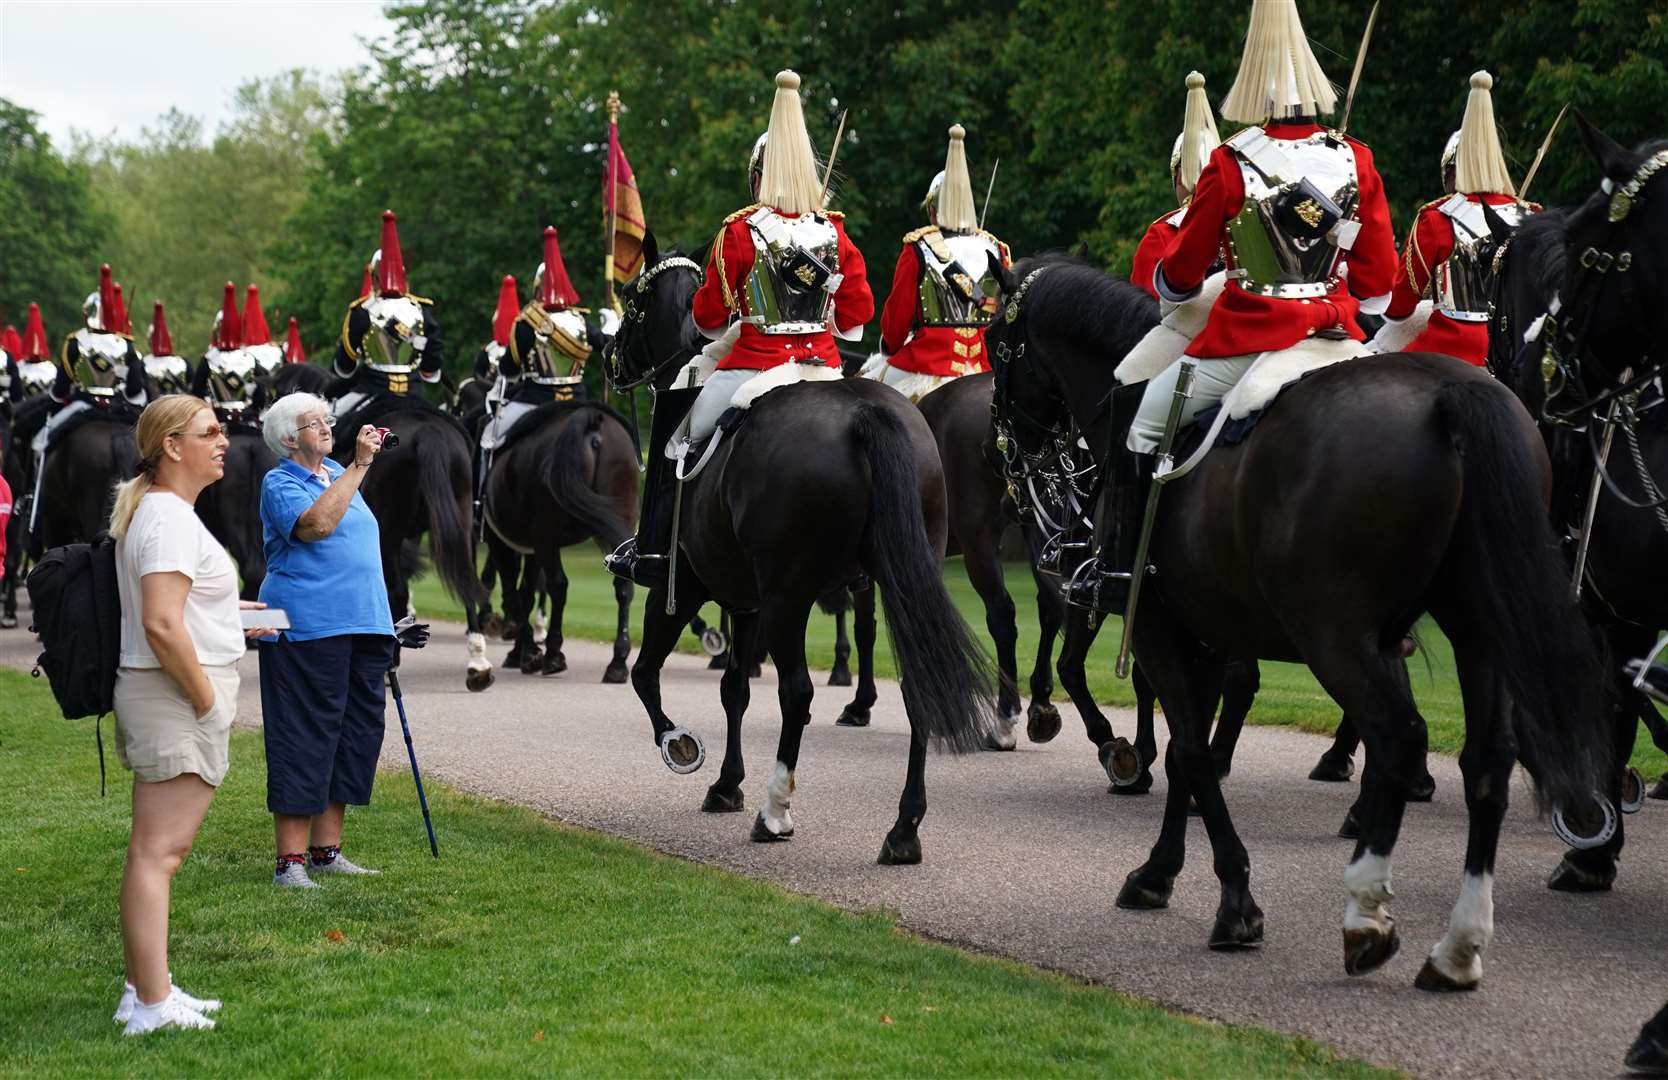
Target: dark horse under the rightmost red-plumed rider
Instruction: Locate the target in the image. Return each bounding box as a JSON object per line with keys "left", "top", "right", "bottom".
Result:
{"left": 482, "top": 401, "right": 639, "bottom": 683}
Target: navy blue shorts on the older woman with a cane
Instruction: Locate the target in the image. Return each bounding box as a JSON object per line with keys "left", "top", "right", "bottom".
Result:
{"left": 260, "top": 634, "right": 394, "bottom": 816}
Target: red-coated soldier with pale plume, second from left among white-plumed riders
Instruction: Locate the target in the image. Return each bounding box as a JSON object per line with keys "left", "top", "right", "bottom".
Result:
{"left": 862, "top": 124, "right": 1012, "bottom": 402}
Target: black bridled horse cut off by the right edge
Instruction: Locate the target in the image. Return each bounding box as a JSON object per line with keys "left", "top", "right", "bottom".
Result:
{"left": 1490, "top": 114, "right": 1668, "bottom": 891}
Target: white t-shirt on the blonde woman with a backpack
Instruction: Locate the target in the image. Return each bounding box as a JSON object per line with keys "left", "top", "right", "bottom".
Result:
{"left": 115, "top": 491, "right": 244, "bottom": 668}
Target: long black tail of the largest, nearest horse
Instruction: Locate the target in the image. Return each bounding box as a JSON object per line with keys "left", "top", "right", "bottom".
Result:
{"left": 1436, "top": 379, "right": 1610, "bottom": 806}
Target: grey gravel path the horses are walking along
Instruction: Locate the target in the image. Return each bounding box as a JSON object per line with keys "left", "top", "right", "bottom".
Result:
{"left": 0, "top": 621, "right": 1668, "bottom": 1077}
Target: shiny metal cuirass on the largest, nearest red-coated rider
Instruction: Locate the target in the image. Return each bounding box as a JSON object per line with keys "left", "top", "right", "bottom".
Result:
{"left": 1224, "top": 127, "right": 1361, "bottom": 299}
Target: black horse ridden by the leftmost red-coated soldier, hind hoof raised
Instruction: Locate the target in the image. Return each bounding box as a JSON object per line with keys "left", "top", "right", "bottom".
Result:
{"left": 605, "top": 240, "right": 991, "bottom": 863}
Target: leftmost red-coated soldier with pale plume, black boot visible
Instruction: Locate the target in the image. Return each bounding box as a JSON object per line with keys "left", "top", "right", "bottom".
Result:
{"left": 605, "top": 72, "right": 874, "bottom": 588}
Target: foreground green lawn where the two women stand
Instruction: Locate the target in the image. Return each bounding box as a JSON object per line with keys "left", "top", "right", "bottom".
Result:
{"left": 0, "top": 671, "right": 1388, "bottom": 1077}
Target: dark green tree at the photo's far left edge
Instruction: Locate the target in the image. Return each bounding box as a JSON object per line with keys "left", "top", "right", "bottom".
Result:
{"left": 0, "top": 98, "right": 108, "bottom": 337}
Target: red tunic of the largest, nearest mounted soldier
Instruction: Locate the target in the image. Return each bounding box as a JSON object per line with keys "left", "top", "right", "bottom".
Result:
{"left": 1161, "top": 124, "right": 1396, "bottom": 359}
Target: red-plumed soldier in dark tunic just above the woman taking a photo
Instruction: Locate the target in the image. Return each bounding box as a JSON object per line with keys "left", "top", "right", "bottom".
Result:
{"left": 335, "top": 210, "right": 445, "bottom": 416}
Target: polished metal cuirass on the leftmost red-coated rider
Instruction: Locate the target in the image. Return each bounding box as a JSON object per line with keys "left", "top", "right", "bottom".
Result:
{"left": 742, "top": 207, "right": 839, "bottom": 334}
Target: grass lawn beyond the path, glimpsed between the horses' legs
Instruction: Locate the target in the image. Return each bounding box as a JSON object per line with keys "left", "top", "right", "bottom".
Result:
{"left": 414, "top": 544, "right": 1668, "bottom": 778}
